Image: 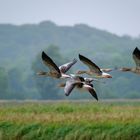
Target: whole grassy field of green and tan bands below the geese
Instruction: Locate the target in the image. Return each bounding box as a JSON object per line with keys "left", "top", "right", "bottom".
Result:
{"left": 0, "top": 100, "right": 140, "bottom": 140}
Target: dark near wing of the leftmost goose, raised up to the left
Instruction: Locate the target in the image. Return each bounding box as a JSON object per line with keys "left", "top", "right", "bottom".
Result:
{"left": 42, "top": 51, "right": 60, "bottom": 74}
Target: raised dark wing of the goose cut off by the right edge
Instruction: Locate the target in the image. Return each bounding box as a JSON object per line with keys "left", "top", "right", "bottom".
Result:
{"left": 133, "top": 47, "right": 140, "bottom": 68}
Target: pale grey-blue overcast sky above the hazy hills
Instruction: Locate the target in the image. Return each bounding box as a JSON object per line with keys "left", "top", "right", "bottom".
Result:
{"left": 0, "top": 0, "right": 140, "bottom": 37}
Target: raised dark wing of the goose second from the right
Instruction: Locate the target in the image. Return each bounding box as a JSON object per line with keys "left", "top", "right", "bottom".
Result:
{"left": 79, "top": 54, "right": 102, "bottom": 74}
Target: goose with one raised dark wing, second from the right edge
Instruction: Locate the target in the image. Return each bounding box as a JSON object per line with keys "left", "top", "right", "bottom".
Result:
{"left": 76, "top": 54, "right": 112, "bottom": 78}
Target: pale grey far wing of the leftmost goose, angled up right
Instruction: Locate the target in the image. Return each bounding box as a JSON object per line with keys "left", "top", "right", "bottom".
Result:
{"left": 59, "top": 59, "right": 77, "bottom": 73}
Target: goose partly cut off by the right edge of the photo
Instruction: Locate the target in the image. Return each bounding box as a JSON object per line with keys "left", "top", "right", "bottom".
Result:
{"left": 119, "top": 47, "right": 140, "bottom": 74}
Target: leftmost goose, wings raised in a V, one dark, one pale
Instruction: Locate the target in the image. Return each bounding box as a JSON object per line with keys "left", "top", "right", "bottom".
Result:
{"left": 37, "top": 51, "right": 77, "bottom": 79}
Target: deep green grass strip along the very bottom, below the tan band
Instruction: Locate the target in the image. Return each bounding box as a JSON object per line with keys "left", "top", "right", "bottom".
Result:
{"left": 0, "top": 122, "right": 140, "bottom": 140}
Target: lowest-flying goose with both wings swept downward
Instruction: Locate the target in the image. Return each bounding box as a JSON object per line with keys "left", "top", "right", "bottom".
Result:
{"left": 59, "top": 76, "right": 98, "bottom": 101}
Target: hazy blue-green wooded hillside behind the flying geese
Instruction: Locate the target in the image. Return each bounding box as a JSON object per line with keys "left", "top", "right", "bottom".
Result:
{"left": 0, "top": 21, "right": 140, "bottom": 99}
